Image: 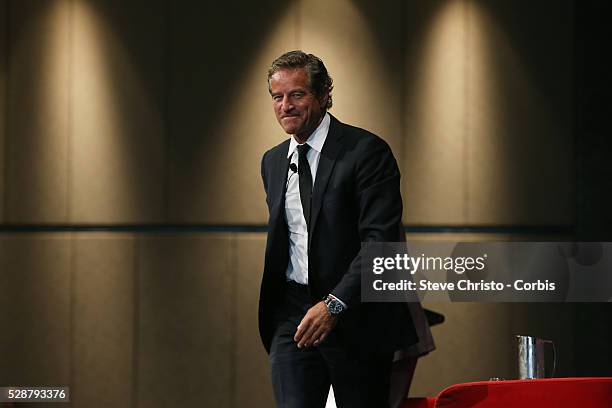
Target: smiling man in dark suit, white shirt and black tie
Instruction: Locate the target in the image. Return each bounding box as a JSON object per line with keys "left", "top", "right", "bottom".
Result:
{"left": 259, "top": 51, "right": 433, "bottom": 408}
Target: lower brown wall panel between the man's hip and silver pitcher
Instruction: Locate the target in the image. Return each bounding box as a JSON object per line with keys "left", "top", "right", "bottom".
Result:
{"left": 410, "top": 303, "right": 516, "bottom": 396}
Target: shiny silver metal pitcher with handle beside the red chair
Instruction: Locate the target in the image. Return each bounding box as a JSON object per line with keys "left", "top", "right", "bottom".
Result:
{"left": 516, "top": 336, "right": 557, "bottom": 380}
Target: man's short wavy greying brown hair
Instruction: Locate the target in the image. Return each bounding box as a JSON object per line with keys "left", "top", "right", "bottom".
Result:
{"left": 268, "top": 50, "right": 334, "bottom": 109}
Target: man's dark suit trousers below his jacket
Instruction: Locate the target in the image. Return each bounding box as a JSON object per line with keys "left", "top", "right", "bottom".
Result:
{"left": 270, "top": 282, "right": 393, "bottom": 408}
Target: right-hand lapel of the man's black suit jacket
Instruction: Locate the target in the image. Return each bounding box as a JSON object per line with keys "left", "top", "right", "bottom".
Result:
{"left": 308, "top": 115, "right": 342, "bottom": 248}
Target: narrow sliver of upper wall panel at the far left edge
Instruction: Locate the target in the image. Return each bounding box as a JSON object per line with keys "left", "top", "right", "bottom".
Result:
{"left": 0, "top": 0, "right": 8, "bottom": 222}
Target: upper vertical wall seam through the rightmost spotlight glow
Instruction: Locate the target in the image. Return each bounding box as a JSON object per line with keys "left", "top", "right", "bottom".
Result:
{"left": 462, "top": 0, "right": 471, "bottom": 224}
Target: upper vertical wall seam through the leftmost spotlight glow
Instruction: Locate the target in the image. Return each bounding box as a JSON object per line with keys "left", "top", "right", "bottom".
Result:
{"left": 64, "top": 0, "right": 76, "bottom": 222}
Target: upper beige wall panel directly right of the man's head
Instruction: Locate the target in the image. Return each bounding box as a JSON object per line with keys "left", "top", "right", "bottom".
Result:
{"left": 298, "top": 0, "right": 403, "bottom": 156}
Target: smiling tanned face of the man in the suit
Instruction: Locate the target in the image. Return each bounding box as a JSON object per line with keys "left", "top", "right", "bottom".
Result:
{"left": 270, "top": 68, "right": 327, "bottom": 143}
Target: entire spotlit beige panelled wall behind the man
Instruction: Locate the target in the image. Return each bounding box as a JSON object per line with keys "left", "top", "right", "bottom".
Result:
{"left": 0, "top": 0, "right": 612, "bottom": 407}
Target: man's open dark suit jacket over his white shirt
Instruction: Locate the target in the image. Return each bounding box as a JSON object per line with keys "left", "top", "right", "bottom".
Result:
{"left": 259, "top": 116, "right": 433, "bottom": 354}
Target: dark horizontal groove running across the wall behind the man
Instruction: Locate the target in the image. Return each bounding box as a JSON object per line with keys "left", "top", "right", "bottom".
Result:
{"left": 0, "top": 224, "right": 575, "bottom": 235}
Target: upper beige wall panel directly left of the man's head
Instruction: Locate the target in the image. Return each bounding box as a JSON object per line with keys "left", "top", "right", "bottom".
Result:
{"left": 168, "top": 1, "right": 296, "bottom": 223}
